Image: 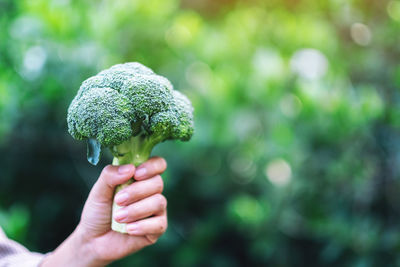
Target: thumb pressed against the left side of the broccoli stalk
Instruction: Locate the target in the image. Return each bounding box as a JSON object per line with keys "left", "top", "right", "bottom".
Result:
{"left": 89, "top": 164, "right": 135, "bottom": 203}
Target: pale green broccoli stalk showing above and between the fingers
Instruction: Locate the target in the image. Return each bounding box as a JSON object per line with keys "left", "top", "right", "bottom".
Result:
{"left": 111, "top": 136, "right": 155, "bottom": 233}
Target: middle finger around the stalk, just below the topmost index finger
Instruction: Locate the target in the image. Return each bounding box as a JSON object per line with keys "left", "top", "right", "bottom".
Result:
{"left": 115, "top": 175, "right": 164, "bottom": 206}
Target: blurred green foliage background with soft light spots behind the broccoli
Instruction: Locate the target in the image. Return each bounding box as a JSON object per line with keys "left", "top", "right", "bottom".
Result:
{"left": 0, "top": 0, "right": 400, "bottom": 267}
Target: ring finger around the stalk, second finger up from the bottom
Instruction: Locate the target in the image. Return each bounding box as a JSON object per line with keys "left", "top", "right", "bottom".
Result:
{"left": 114, "top": 194, "right": 167, "bottom": 223}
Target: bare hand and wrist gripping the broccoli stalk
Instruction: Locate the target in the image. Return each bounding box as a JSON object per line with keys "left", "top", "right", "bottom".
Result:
{"left": 41, "top": 157, "right": 167, "bottom": 267}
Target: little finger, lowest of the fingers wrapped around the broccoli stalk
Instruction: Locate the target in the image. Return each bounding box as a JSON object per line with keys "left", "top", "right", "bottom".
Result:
{"left": 126, "top": 213, "right": 168, "bottom": 236}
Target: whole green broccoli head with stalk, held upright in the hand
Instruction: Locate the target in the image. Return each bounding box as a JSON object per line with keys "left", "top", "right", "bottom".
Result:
{"left": 67, "top": 62, "right": 194, "bottom": 233}
